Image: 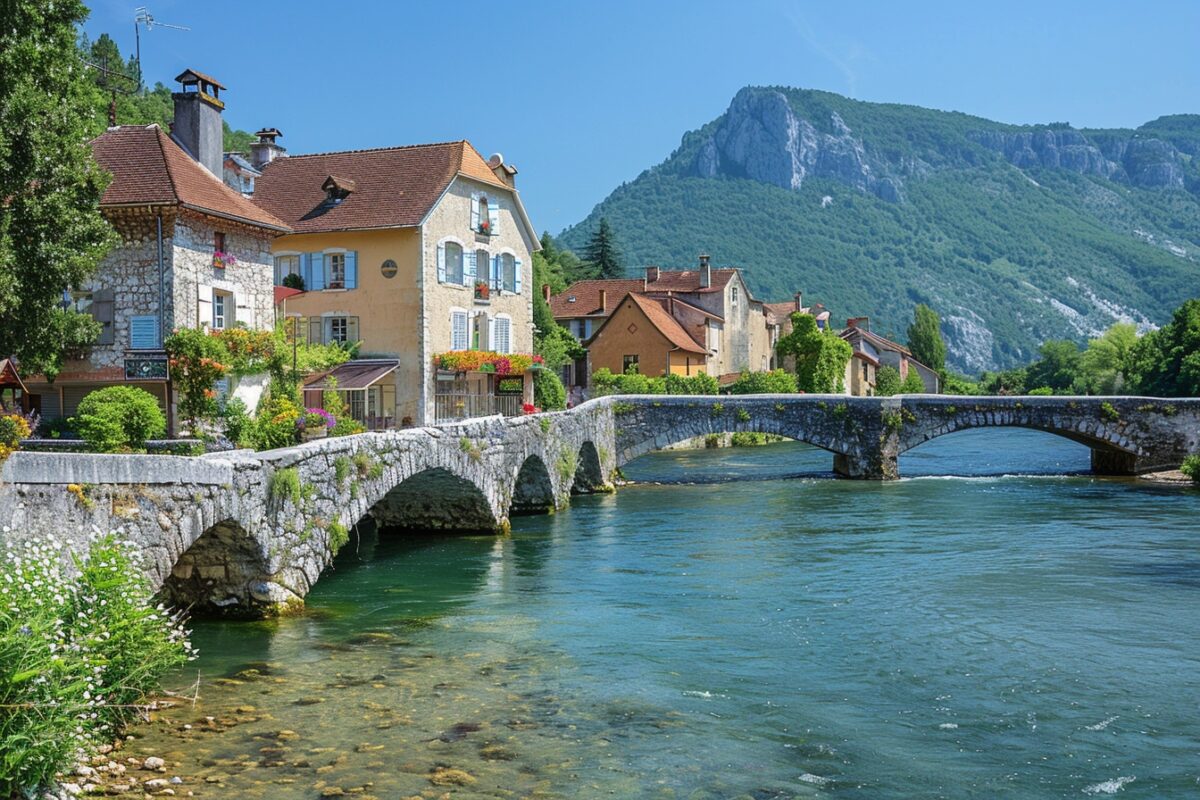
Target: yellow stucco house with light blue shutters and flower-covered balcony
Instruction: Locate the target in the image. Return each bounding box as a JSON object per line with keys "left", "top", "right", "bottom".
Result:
{"left": 252, "top": 130, "right": 539, "bottom": 428}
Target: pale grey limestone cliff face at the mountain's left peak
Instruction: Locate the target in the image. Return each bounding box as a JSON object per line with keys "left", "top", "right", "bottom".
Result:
{"left": 694, "top": 88, "right": 904, "bottom": 201}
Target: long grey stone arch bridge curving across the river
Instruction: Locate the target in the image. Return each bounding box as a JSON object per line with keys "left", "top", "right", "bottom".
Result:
{"left": 0, "top": 395, "right": 1200, "bottom": 615}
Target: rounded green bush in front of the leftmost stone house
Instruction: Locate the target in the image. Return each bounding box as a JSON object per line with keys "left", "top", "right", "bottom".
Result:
{"left": 71, "top": 386, "right": 167, "bottom": 452}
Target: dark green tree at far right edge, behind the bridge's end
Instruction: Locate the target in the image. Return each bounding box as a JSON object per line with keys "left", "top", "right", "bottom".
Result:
{"left": 1130, "top": 300, "right": 1200, "bottom": 397}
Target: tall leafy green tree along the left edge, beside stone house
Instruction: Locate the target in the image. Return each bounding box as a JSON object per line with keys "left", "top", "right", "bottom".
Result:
{"left": 0, "top": 0, "right": 115, "bottom": 377}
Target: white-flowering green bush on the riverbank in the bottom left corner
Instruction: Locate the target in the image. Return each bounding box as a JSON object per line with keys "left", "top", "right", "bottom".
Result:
{"left": 0, "top": 531, "right": 194, "bottom": 798}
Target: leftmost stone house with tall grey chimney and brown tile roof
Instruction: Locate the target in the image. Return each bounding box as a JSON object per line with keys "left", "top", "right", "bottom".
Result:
{"left": 26, "top": 70, "right": 288, "bottom": 428}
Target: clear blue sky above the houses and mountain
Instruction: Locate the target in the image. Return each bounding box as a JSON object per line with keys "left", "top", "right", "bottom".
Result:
{"left": 85, "top": 0, "right": 1200, "bottom": 233}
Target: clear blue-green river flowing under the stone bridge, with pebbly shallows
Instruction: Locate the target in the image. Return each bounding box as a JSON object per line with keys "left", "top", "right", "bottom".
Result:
{"left": 130, "top": 429, "right": 1200, "bottom": 800}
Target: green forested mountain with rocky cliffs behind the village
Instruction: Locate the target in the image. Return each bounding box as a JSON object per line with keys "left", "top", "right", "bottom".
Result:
{"left": 559, "top": 86, "right": 1200, "bottom": 373}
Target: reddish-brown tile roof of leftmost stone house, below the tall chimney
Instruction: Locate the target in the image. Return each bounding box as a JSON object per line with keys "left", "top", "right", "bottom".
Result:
{"left": 91, "top": 125, "right": 288, "bottom": 231}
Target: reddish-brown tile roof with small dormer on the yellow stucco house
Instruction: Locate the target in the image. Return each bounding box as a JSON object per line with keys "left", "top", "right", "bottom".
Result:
{"left": 254, "top": 142, "right": 510, "bottom": 233}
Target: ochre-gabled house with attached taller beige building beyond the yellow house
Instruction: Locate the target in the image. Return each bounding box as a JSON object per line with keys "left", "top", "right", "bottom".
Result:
{"left": 544, "top": 255, "right": 779, "bottom": 386}
